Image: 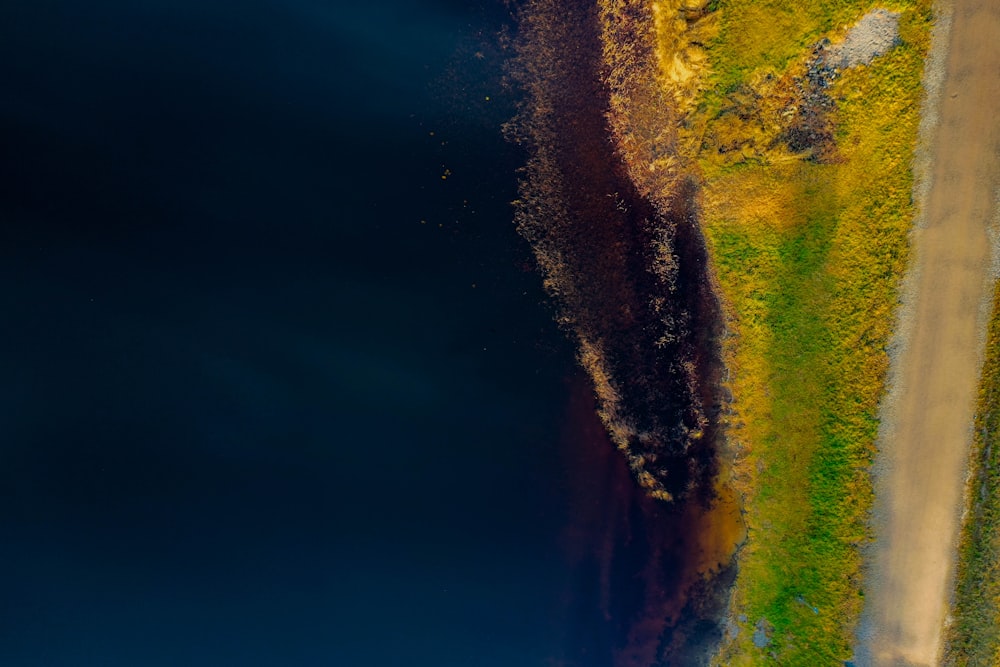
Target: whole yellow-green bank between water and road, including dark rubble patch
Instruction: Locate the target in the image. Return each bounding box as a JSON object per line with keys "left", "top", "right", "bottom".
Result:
{"left": 606, "top": 0, "right": 932, "bottom": 665}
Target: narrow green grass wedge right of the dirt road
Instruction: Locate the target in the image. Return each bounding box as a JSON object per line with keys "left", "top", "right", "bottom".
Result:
{"left": 945, "top": 290, "right": 1000, "bottom": 667}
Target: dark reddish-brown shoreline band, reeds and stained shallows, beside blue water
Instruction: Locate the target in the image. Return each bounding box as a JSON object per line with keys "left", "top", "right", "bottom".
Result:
{"left": 508, "top": 0, "right": 743, "bottom": 667}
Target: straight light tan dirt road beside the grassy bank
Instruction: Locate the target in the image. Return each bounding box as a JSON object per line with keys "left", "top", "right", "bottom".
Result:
{"left": 857, "top": 0, "right": 1000, "bottom": 667}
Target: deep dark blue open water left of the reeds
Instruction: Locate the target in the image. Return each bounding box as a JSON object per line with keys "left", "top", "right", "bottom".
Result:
{"left": 0, "top": 0, "right": 624, "bottom": 667}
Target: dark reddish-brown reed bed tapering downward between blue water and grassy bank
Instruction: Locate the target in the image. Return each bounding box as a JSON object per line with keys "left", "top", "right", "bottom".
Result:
{"left": 510, "top": 0, "right": 722, "bottom": 499}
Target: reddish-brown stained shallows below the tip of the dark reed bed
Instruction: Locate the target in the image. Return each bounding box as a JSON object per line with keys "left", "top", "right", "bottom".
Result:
{"left": 563, "top": 378, "right": 740, "bottom": 667}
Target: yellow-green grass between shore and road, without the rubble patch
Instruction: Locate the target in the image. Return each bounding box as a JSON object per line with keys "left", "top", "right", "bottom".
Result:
{"left": 691, "top": 0, "right": 930, "bottom": 667}
